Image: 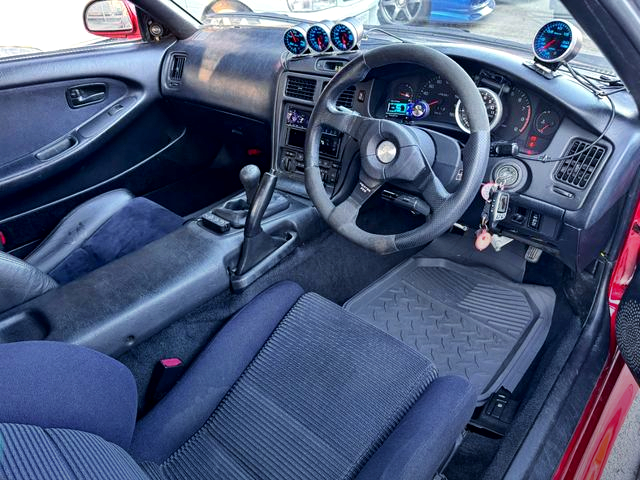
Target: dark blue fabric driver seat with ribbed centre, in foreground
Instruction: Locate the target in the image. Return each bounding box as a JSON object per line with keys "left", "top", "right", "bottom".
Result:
{"left": 0, "top": 282, "right": 476, "bottom": 480}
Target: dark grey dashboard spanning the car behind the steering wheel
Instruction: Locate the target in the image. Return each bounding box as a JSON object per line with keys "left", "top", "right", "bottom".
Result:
{"left": 161, "top": 26, "right": 640, "bottom": 270}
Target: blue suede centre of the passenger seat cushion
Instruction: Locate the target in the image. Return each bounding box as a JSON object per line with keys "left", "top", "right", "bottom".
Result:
{"left": 48, "top": 197, "right": 183, "bottom": 284}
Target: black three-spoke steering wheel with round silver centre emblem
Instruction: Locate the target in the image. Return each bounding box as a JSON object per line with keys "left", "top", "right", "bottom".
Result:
{"left": 305, "top": 43, "right": 491, "bottom": 254}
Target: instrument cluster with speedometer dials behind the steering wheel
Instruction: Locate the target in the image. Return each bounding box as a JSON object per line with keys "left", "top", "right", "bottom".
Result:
{"left": 374, "top": 69, "right": 562, "bottom": 155}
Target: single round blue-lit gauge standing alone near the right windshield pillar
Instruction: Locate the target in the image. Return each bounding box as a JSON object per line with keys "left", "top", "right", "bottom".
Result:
{"left": 533, "top": 20, "right": 582, "bottom": 63}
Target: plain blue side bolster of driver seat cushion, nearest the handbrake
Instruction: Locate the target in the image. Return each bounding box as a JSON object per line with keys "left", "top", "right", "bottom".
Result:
{"left": 130, "top": 282, "right": 304, "bottom": 463}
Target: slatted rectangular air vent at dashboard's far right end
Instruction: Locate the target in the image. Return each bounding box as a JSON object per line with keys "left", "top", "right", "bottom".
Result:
{"left": 555, "top": 140, "right": 606, "bottom": 189}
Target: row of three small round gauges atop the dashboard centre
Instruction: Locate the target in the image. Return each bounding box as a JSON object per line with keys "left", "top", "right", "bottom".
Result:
{"left": 284, "top": 18, "right": 364, "bottom": 55}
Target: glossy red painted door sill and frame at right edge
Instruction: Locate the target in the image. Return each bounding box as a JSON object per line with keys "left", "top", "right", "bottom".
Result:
{"left": 553, "top": 196, "right": 640, "bottom": 480}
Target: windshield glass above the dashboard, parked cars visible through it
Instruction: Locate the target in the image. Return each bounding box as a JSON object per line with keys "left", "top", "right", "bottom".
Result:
{"left": 173, "top": 0, "right": 604, "bottom": 65}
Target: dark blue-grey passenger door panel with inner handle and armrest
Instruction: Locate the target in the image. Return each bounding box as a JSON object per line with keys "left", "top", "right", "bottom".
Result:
{"left": 0, "top": 42, "right": 215, "bottom": 254}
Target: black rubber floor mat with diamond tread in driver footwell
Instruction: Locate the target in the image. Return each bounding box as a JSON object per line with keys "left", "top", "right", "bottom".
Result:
{"left": 345, "top": 257, "right": 555, "bottom": 405}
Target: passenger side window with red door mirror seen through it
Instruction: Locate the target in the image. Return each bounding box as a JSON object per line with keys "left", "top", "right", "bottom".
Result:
{"left": 0, "top": 0, "right": 140, "bottom": 58}
